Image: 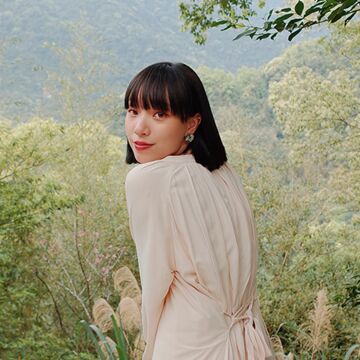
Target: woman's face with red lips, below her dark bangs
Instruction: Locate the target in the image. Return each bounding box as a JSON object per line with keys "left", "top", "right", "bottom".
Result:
{"left": 125, "top": 106, "right": 190, "bottom": 163}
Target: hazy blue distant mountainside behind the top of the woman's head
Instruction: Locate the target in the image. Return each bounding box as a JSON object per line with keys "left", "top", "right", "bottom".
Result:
{"left": 0, "top": 0, "right": 298, "bottom": 127}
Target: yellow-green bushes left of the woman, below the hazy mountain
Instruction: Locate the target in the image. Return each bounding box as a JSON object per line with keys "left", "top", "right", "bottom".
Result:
{"left": 0, "top": 119, "right": 134, "bottom": 359}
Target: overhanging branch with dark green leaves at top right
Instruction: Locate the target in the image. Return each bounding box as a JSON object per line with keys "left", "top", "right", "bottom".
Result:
{"left": 179, "top": 0, "right": 360, "bottom": 44}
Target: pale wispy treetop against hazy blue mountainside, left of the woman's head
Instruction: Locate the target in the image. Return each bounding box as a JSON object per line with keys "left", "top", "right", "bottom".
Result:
{"left": 42, "top": 16, "right": 120, "bottom": 125}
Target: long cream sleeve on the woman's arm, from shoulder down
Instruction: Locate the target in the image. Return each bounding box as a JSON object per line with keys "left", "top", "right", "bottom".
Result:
{"left": 125, "top": 164, "right": 175, "bottom": 360}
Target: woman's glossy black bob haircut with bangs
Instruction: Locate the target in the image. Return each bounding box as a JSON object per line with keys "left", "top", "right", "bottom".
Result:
{"left": 125, "top": 62, "right": 227, "bottom": 171}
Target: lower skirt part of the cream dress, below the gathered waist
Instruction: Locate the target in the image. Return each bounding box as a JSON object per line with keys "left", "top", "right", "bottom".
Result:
{"left": 153, "top": 272, "right": 271, "bottom": 360}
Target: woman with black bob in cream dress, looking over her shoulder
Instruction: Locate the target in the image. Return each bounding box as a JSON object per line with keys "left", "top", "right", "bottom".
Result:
{"left": 125, "top": 62, "right": 272, "bottom": 360}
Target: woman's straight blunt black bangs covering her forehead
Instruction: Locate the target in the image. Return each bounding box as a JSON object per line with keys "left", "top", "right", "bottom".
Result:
{"left": 124, "top": 63, "right": 197, "bottom": 122}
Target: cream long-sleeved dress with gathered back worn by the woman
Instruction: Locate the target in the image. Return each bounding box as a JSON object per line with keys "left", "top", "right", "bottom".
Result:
{"left": 126, "top": 154, "right": 273, "bottom": 360}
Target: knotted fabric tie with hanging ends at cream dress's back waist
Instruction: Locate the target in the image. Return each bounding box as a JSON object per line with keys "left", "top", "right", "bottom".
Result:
{"left": 224, "top": 304, "right": 272, "bottom": 360}
